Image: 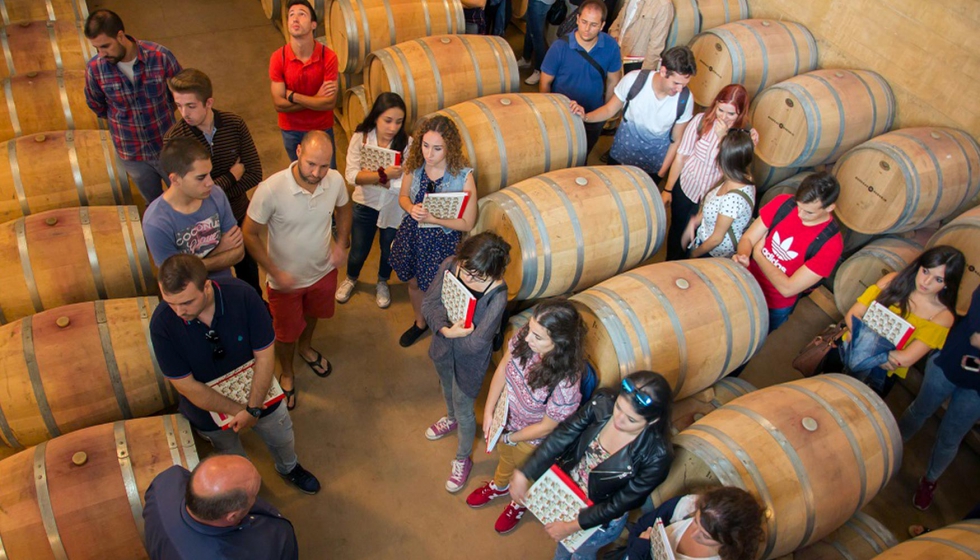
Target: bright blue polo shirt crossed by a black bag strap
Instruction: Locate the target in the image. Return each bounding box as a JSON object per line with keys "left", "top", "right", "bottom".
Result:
{"left": 541, "top": 31, "right": 623, "bottom": 112}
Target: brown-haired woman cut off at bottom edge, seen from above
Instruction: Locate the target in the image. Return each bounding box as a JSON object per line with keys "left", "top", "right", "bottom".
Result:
{"left": 626, "top": 487, "right": 765, "bottom": 560}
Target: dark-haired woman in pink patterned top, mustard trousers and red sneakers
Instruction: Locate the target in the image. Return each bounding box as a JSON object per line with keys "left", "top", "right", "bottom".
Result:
{"left": 466, "top": 298, "right": 585, "bottom": 535}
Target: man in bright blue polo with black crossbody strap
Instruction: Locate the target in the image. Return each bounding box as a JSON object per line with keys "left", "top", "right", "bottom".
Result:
{"left": 539, "top": 0, "right": 623, "bottom": 154}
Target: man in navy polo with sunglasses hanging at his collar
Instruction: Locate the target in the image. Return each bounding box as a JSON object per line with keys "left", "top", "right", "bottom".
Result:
{"left": 150, "top": 253, "right": 320, "bottom": 494}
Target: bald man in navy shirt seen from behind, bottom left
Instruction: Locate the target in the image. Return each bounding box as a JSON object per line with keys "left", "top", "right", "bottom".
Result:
{"left": 143, "top": 455, "right": 299, "bottom": 560}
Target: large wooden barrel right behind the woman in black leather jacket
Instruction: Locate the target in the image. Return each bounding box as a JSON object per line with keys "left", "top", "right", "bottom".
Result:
{"left": 653, "top": 374, "right": 902, "bottom": 558}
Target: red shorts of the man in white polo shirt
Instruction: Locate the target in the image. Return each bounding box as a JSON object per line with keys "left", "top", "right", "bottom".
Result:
{"left": 267, "top": 269, "right": 337, "bottom": 344}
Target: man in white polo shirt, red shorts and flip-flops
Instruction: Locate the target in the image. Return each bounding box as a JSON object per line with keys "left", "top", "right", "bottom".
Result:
{"left": 243, "top": 131, "right": 353, "bottom": 410}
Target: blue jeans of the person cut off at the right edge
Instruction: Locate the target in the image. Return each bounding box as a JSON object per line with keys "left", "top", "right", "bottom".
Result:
{"left": 898, "top": 352, "right": 980, "bottom": 482}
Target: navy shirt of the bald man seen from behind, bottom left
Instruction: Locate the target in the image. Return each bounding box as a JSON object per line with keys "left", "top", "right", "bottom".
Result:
{"left": 143, "top": 466, "right": 299, "bottom": 560}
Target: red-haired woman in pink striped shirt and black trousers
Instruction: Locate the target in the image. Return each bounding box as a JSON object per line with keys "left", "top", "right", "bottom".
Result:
{"left": 661, "top": 84, "right": 759, "bottom": 260}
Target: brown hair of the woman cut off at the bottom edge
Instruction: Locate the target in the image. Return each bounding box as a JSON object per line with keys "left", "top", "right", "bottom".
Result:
{"left": 696, "top": 486, "right": 765, "bottom": 560}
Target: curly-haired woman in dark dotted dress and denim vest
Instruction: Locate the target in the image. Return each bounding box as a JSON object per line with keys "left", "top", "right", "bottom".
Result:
{"left": 389, "top": 115, "right": 477, "bottom": 347}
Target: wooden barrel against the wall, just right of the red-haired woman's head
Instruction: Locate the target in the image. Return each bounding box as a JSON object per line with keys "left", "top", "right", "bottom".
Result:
{"left": 750, "top": 70, "right": 896, "bottom": 167}
